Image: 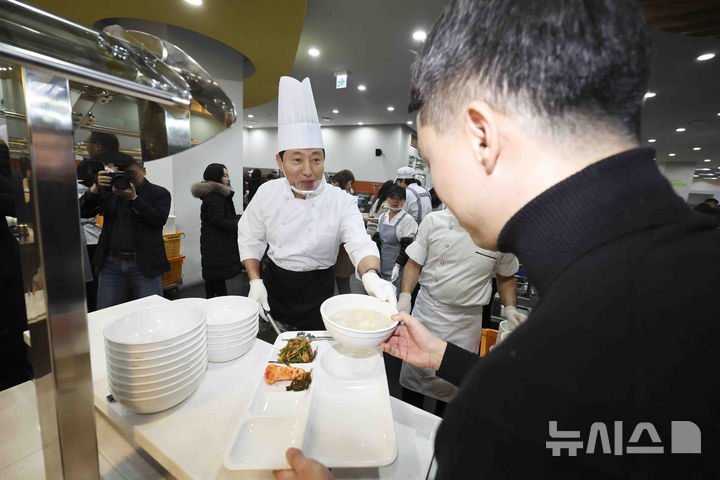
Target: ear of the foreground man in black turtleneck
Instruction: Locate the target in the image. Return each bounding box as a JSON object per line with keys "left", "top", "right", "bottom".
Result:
{"left": 463, "top": 100, "right": 500, "bottom": 175}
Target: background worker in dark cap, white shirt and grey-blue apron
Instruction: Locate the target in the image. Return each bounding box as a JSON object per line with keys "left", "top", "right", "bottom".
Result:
{"left": 377, "top": 185, "right": 418, "bottom": 290}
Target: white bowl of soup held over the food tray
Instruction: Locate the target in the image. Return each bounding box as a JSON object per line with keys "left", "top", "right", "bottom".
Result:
{"left": 320, "top": 294, "right": 398, "bottom": 348}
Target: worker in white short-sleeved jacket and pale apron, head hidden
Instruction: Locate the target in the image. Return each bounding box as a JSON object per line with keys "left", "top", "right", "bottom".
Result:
{"left": 398, "top": 209, "right": 525, "bottom": 406}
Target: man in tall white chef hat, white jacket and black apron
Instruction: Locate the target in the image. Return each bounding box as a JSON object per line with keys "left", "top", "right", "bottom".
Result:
{"left": 238, "top": 77, "right": 396, "bottom": 330}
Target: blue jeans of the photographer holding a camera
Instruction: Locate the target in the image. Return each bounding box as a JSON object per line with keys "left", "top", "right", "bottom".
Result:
{"left": 97, "top": 255, "right": 162, "bottom": 310}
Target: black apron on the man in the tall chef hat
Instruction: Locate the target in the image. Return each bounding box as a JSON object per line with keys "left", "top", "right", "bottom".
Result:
{"left": 263, "top": 258, "right": 335, "bottom": 330}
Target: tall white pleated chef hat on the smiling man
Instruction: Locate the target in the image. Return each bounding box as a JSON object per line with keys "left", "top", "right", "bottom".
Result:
{"left": 278, "top": 77, "right": 323, "bottom": 152}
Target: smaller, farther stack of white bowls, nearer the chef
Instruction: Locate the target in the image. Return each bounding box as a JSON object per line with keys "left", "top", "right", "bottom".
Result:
{"left": 197, "top": 295, "right": 258, "bottom": 363}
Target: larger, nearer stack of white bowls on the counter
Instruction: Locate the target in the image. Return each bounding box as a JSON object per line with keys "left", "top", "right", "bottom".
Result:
{"left": 103, "top": 304, "right": 207, "bottom": 413}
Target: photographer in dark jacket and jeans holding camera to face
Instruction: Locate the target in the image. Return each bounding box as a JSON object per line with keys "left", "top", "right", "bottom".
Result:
{"left": 80, "top": 152, "right": 170, "bottom": 309}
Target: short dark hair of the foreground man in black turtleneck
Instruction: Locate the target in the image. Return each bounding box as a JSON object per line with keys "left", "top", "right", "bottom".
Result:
{"left": 409, "top": 0, "right": 650, "bottom": 139}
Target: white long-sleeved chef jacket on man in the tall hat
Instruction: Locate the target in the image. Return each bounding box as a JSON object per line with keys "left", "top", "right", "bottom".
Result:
{"left": 238, "top": 178, "right": 379, "bottom": 272}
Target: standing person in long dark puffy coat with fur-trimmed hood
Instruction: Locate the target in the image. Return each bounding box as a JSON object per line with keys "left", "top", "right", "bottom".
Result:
{"left": 191, "top": 163, "right": 240, "bottom": 298}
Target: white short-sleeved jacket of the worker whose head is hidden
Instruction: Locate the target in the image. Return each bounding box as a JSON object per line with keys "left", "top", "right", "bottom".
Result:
{"left": 405, "top": 209, "right": 519, "bottom": 306}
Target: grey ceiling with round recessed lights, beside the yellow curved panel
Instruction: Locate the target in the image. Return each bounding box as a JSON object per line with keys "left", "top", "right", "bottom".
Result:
{"left": 244, "top": 0, "right": 720, "bottom": 176}
